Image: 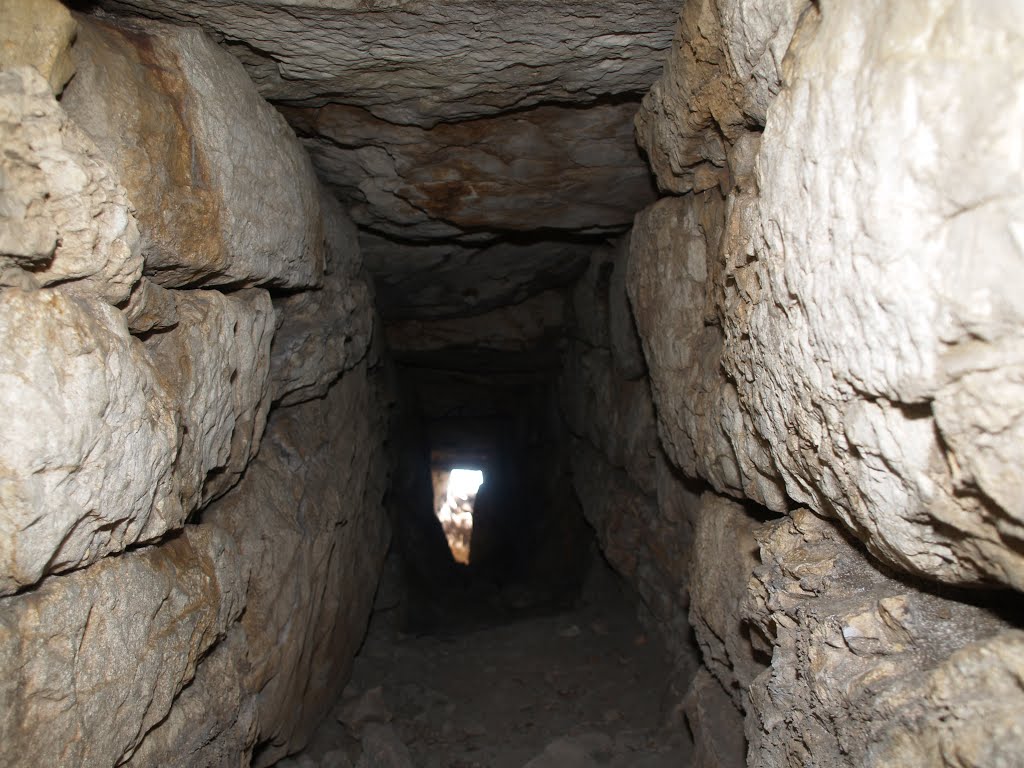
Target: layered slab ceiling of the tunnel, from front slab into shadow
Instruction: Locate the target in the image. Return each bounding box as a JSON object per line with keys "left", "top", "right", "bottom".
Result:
{"left": 99, "top": 0, "right": 679, "bottom": 319}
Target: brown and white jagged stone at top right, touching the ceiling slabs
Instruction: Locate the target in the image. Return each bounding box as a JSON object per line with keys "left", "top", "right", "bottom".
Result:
{"left": 636, "top": 0, "right": 812, "bottom": 194}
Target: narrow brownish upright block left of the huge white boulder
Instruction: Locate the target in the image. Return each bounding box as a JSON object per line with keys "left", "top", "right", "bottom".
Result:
{"left": 627, "top": 190, "right": 786, "bottom": 511}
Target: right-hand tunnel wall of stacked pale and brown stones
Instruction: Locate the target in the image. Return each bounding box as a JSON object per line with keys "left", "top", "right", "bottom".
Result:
{"left": 614, "top": 0, "right": 1024, "bottom": 767}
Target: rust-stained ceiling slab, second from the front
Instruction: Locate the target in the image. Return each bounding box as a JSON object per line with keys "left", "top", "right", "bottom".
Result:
{"left": 284, "top": 101, "right": 654, "bottom": 240}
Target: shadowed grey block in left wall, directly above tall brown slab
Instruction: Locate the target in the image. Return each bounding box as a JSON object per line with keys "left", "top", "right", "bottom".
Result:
{"left": 270, "top": 189, "right": 374, "bottom": 406}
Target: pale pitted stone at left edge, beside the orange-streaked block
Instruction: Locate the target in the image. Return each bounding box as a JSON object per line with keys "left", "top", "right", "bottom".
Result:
{"left": 0, "top": 67, "right": 142, "bottom": 304}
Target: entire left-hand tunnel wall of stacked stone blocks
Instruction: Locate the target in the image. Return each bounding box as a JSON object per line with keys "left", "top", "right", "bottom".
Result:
{"left": 0, "top": 9, "right": 389, "bottom": 768}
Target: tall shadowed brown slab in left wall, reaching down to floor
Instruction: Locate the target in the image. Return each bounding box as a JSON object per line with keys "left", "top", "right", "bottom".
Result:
{"left": 203, "top": 361, "right": 389, "bottom": 766}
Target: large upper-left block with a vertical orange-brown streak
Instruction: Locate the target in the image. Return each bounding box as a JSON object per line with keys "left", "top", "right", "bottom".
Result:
{"left": 62, "top": 16, "right": 324, "bottom": 289}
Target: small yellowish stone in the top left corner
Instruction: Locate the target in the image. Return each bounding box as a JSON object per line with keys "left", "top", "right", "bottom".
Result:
{"left": 0, "top": 0, "right": 77, "bottom": 94}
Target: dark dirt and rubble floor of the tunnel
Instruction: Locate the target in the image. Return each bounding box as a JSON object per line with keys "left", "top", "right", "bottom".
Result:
{"left": 278, "top": 569, "right": 691, "bottom": 768}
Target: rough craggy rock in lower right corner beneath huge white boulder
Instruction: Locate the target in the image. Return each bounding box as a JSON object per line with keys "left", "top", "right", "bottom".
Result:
{"left": 746, "top": 510, "right": 1024, "bottom": 768}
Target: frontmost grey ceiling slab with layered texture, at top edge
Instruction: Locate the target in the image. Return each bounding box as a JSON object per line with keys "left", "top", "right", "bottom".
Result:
{"left": 96, "top": 0, "right": 679, "bottom": 126}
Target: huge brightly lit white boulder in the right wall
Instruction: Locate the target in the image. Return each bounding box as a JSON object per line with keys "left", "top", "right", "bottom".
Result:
{"left": 722, "top": 0, "right": 1024, "bottom": 589}
